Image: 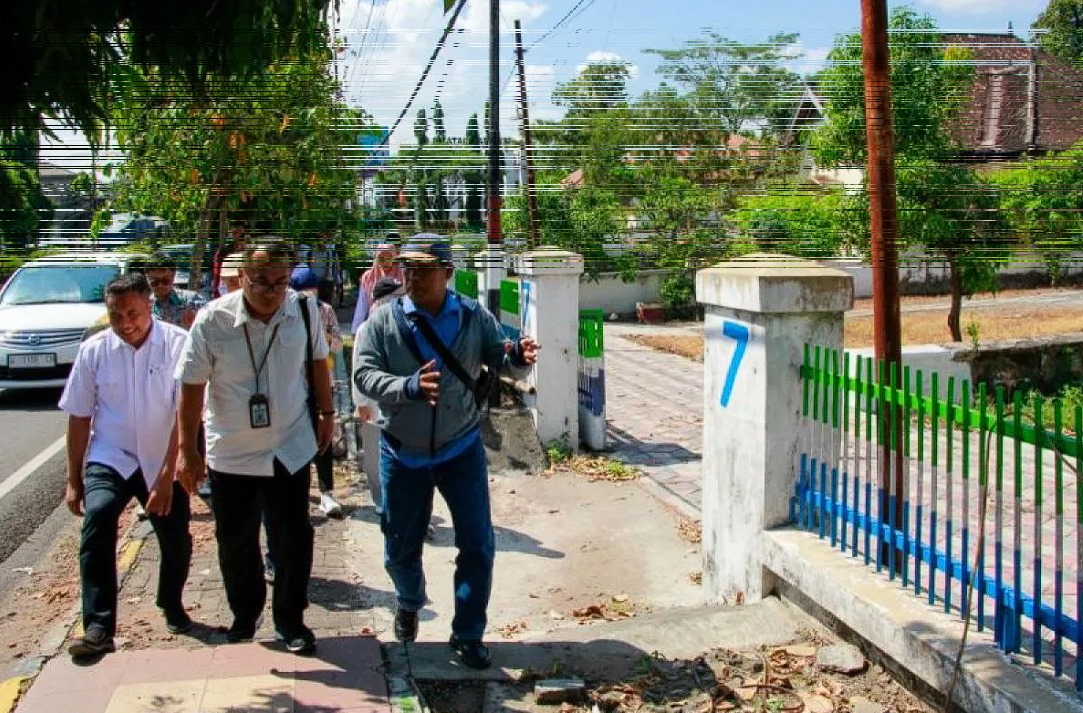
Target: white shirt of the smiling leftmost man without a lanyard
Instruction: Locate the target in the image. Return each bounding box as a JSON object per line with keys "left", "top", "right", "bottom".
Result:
{"left": 60, "top": 320, "right": 187, "bottom": 489}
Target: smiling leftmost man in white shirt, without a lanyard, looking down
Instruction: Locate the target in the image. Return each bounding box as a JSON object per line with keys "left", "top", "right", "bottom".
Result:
{"left": 60, "top": 274, "right": 192, "bottom": 657}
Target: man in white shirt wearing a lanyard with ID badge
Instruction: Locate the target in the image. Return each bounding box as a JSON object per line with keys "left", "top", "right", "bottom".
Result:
{"left": 177, "top": 237, "right": 335, "bottom": 653}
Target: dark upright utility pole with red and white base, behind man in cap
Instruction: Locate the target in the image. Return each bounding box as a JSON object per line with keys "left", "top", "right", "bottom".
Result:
{"left": 485, "top": 0, "right": 507, "bottom": 316}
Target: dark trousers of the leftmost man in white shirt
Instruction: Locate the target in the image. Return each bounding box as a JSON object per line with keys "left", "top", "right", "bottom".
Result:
{"left": 79, "top": 463, "right": 192, "bottom": 636}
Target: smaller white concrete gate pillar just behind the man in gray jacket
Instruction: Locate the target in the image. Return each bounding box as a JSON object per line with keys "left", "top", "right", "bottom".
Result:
{"left": 519, "top": 247, "right": 583, "bottom": 450}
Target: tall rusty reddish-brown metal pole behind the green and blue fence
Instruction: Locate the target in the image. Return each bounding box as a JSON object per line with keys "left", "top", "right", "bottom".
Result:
{"left": 861, "top": 0, "right": 906, "bottom": 569}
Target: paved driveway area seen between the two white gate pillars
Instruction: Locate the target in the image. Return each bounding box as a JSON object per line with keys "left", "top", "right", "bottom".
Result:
{"left": 605, "top": 324, "right": 703, "bottom": 511}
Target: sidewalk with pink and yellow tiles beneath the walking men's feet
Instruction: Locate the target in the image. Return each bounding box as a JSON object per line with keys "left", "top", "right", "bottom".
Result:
{"left": 16, "top": 468, "right": 390, "bottom": 713}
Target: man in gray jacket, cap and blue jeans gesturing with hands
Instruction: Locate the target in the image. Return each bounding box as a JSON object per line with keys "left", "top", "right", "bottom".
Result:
{"left": 353, "top": 233, "right": 539, "bottom": 669}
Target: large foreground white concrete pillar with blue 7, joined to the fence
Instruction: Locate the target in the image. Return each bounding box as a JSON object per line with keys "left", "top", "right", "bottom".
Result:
{"left": 695, "top": 255, "right": 853, "bottom": 605}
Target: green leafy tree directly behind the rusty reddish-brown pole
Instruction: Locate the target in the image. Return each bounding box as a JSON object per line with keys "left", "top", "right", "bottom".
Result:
{"left": 811, "top": 8, "right": 1000, "bottom": 341}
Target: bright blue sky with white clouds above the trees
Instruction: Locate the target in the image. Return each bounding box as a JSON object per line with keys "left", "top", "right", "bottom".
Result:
{"left": 48, "top": 0, "right": 1046, "bottom": 168}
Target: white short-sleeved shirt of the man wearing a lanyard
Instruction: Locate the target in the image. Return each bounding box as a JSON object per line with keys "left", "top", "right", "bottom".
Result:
{"left": 177, "top": 290, "right": 328, "bottom": 477}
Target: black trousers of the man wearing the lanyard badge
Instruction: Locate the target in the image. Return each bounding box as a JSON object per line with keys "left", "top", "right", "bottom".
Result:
{"left": 210, "top": 461, "right": 314, "bottom": 635}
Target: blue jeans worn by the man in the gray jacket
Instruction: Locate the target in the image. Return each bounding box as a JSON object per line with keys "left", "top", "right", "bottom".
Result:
{"left": 380, "top": 438, "right": 496, "bottom": 641}
